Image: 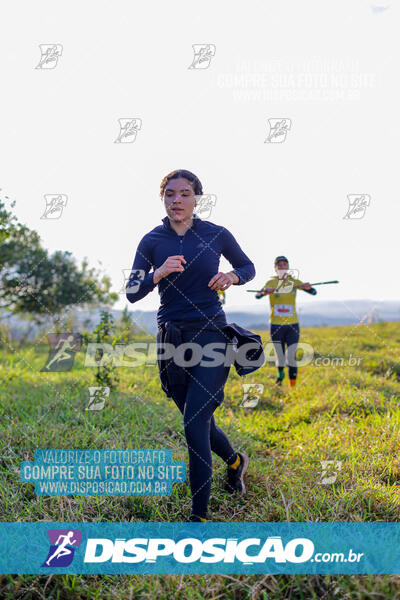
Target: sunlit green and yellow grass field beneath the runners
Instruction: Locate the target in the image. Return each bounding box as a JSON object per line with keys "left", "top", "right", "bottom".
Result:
{"left": 0, "top": 323, "right": 400, "bottom": 600}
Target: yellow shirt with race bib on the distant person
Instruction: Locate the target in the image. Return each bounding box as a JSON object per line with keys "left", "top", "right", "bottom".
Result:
{"left": 264, "top": 275, "right": 303, "bottom": 325}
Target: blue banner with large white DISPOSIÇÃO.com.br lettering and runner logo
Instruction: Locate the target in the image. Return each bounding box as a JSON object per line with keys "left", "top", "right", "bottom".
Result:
{"left": 0, "top": 522, "right": 400, "bottom": 574}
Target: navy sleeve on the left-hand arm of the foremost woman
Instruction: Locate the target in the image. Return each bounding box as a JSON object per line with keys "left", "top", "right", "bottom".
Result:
{"left": 125, "top": 236, "right": 157, "bottom": 302}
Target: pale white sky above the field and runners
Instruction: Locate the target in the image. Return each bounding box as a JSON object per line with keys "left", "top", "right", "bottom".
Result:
{"left": 0, "top": 0, "right": 400, "bottom": 310}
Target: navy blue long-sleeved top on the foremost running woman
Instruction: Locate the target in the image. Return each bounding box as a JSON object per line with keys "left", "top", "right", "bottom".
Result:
{"left": 126, "top": 215, "right": 256, "bottom": 324}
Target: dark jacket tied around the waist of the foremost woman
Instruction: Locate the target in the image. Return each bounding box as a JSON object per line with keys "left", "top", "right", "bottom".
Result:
{"left": 157, "top": 321, "right": 265, "bottom": 397}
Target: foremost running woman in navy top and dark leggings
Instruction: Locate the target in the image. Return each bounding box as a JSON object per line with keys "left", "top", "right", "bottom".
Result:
{"left": 127, "top": 169, "right": 255, "bottom": 521}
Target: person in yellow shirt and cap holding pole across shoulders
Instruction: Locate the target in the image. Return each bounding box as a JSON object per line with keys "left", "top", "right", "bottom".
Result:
{"left": 256, "top": 256, "right": 317, "bottom": 387}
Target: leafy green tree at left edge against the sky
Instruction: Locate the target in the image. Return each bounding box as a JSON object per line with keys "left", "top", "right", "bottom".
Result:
{"left": 0, "top": 200, "right": 118, "bottom": 323}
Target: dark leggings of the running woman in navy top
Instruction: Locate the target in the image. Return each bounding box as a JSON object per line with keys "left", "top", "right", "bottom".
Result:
{"left": 164, "top": 330, "right": 236, "bottom": 518}
